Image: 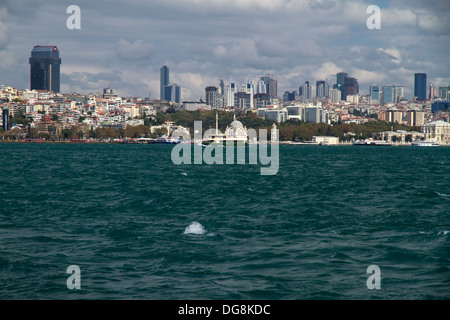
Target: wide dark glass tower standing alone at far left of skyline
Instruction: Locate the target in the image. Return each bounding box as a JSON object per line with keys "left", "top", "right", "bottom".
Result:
{"left": 29, "top": 46, "right": 61, "bottom": 92}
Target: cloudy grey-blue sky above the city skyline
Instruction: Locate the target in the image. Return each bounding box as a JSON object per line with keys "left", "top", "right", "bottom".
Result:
{"left": 0, "top": 0, "right": 450, "bottom": 100}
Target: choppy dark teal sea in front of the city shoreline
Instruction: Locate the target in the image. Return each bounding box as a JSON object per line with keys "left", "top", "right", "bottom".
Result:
{"left": 0, "top": 143, "right": 450, "bottom": 300}
